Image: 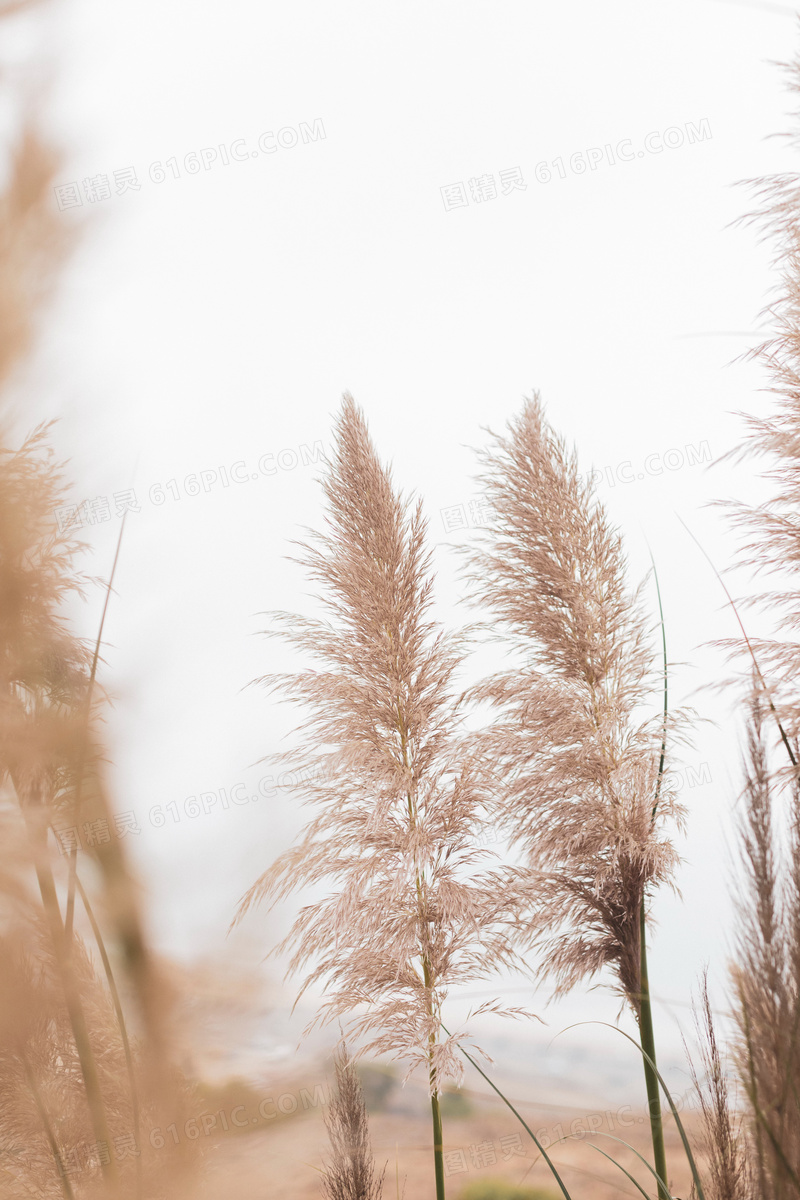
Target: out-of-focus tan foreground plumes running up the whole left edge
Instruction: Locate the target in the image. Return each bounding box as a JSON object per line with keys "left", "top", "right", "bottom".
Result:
{"left": 0, "top": 4, "right": 196, "bottom": 1200}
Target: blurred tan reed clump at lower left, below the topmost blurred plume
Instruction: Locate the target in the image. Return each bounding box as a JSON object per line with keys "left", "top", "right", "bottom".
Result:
{"left": 0, "top": 415, "right": 195, "bottom": 1198}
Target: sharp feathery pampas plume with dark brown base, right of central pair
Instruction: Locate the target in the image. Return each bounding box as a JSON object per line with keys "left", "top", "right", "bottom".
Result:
{"left": 469, "top": 394, "right": 681, "bottom": 1014}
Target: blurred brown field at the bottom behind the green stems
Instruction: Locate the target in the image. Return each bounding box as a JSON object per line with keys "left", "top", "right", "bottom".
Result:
{"left": 142, "top": 1022, "right": 697, "bottom": 1200}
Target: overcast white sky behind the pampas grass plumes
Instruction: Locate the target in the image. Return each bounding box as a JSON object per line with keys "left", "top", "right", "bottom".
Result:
{"left": 10, "top": 0, "right": 798, "bottom": 1080}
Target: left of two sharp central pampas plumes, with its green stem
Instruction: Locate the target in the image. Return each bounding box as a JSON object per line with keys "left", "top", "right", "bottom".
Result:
{"left": 236, "top": 395, "right": 532, "bottom": 1189}
